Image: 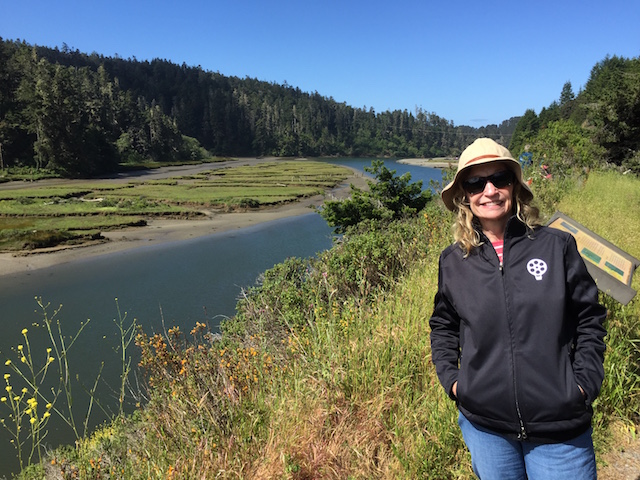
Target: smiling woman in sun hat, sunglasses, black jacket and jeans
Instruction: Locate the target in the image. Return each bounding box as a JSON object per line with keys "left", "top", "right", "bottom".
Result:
{"left": 429, "top": 138, "right": 606, "bottom": 480}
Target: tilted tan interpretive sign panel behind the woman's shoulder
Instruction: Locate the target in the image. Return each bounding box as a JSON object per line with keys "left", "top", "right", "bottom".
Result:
{"left": 547, "top": 212, "right": 640, "bottom": 305}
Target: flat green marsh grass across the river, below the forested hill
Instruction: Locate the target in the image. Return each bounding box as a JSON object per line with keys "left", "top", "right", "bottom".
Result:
{"left": 0, "top": 161, "right": 350, "bottom": 251}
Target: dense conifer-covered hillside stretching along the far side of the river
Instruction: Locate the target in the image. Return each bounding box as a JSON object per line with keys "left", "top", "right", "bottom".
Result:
{"left": 0, "top": 39, "right": 517, "bottom": 175}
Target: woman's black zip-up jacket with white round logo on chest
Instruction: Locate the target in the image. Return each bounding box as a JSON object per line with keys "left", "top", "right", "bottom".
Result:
{"left": 429, "top": 217, "right": 606, "bottom": 442}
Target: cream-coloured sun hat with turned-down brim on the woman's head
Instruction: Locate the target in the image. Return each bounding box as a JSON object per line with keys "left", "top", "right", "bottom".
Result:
{"left": 441, "top": 138, "right": 533, "bottom": 211}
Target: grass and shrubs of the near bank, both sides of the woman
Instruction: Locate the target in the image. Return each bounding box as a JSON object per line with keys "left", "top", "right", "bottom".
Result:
{"left": 15, "top": 173, "right": 640, "bottom": 479}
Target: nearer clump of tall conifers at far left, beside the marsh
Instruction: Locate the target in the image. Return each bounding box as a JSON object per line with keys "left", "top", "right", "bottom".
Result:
{"left": 0, "top": 38, "right": 205, "bottom": 176}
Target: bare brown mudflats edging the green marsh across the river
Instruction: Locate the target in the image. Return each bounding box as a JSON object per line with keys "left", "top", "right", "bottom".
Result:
{"left": 0, "top": 158, "right": 367, "bottom": 276}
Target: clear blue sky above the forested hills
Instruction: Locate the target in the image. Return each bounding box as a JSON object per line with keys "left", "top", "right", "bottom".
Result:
{"left": 0, "top": 0, "right": 640, "bottom": 127}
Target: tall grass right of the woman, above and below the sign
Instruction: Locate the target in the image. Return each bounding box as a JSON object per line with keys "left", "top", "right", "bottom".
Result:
{"left": 557, "top": 171, "right": 640, "bottom": 451}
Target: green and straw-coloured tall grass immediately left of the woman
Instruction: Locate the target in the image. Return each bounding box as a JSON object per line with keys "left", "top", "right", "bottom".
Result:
{"left": 255, "top": 218, "right": 471, "bottom": 478}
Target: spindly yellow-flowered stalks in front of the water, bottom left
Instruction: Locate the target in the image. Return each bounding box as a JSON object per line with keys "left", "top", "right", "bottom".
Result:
{"left": 0, "top": 298, "right": 137, "bottom": 478}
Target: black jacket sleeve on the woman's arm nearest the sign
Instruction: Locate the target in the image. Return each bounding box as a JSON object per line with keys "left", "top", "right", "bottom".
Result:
{"left": 564, "top": 236, "right": 607, "bottom": 403}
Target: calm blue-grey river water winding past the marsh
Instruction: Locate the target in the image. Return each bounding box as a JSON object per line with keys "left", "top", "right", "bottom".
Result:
{"left": 0, "top": 159, "right": 441, "bottom": 475}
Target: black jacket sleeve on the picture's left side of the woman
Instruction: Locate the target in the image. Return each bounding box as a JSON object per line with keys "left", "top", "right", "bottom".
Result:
{"left": 429, "top": 256, "right": 460, "bottom": 400}
